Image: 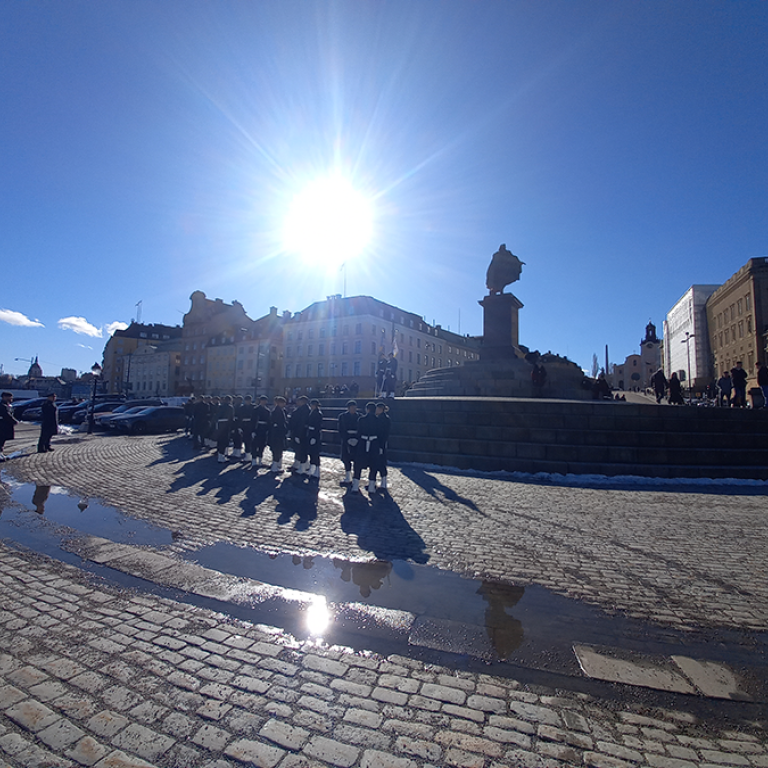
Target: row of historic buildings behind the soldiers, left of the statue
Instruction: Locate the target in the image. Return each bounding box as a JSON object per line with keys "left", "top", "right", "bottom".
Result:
{"left": 103, "top": 291, "right": 480, "bottom": 397}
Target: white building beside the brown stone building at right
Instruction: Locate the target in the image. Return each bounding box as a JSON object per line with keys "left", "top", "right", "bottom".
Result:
{"left": 664, "top": 285, "right": 720, "bottom": 387}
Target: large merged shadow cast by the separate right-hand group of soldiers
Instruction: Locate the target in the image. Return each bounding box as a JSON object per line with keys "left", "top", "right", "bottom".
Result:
{"left": 339, "top": 493, "right": 429, "bottom": 563}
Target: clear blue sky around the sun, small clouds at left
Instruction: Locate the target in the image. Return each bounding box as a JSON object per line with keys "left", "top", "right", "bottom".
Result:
{"left": 0, "top": 0, "right": 768, "bottom": 380}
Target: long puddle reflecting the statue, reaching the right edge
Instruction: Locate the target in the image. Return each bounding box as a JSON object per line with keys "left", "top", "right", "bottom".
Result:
{"left": 183, "top": 542, "right": 766, "bottom": 672}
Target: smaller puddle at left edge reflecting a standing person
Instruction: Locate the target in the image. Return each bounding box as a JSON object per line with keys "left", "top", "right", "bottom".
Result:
{"left": 0, "top": 479, "right": 173, "bottom": 556}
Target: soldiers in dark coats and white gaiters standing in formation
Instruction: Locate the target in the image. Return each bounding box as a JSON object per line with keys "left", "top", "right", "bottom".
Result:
{"left": 185, "top": 395, "right": 390, "bottom": 493}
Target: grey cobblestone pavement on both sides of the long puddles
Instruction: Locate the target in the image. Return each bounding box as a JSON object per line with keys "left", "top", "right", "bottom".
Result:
{"left": 0, "top": 430, "right": 768, "bottom": 768}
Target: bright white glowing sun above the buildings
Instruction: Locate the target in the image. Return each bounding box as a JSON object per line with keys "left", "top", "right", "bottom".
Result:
{"left": 284, "top": 176, "right": 373, "bottom": 268}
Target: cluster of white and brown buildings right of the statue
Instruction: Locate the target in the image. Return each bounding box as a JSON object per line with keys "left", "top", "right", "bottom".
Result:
{"left": 609, "top": 257, "right": 768, "bottom": 392}
